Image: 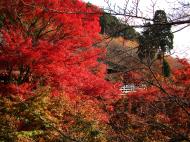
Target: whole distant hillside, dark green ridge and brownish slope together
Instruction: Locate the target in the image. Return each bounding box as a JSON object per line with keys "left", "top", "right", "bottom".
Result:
{"left": 97, "top": 13, "right": 181, "bottom": 81}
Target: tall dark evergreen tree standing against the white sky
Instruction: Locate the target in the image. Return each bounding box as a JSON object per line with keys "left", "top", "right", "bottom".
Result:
{"left": 138, "top": 10, "right": 173, "bottom": 61}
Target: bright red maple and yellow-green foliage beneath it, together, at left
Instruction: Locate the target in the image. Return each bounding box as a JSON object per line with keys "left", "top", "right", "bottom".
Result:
{"left": 0, "top": 0, "right": 119, "bottom": 141}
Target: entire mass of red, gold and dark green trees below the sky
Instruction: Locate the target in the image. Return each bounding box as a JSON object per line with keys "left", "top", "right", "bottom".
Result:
{"left": 0, "top": 0, "right": 190, "bottom": 142}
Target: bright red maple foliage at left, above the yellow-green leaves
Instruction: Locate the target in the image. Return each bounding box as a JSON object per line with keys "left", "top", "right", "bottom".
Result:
{"left": 0, "top": 0, "right": 117, "bottom": 98}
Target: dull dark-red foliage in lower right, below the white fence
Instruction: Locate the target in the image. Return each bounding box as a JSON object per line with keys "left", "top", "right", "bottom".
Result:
{"left": 111, "top": 60, "right": 190, "bottom": 141}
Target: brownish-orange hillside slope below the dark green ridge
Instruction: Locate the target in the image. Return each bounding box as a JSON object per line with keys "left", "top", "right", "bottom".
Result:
{"left": 98, "top": 36, "right": 182, "bottom": 81}
